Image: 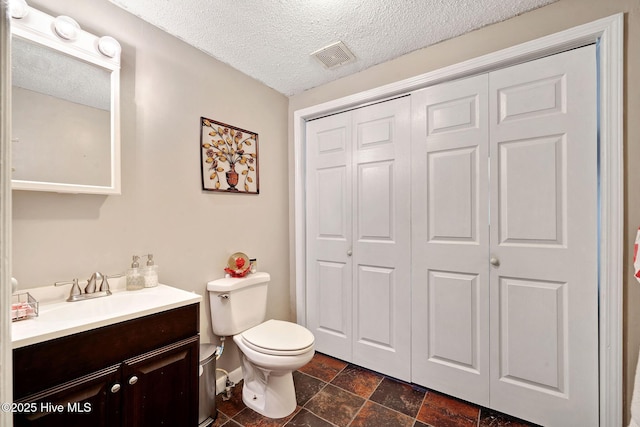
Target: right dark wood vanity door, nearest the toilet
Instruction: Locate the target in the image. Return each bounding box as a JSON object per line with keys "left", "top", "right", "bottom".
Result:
{"left": 122, "top": 336, "right": 199, "bottom": 427}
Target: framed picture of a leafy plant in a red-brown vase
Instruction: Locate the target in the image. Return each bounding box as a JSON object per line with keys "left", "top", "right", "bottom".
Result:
{"left": 200, "top": 117, "right": 260, "bottom": 194}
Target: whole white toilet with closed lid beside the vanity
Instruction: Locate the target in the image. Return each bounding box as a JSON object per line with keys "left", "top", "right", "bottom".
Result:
{"left": 207, "top": 272, "right": 314, "bottom": 418}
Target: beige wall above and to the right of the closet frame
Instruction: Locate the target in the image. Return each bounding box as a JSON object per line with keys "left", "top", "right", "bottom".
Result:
{"left": 289, "top": 0, "right": 640, "bottom": 425}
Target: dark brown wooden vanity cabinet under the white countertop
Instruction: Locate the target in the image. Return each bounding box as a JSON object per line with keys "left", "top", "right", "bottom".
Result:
{"left": 13, "top": 304, "right": 199, "bottom": 427}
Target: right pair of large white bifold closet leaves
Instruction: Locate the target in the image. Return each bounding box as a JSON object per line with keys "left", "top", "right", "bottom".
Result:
{"left": 412, "top": 46, "right": 599, "bottom": 427}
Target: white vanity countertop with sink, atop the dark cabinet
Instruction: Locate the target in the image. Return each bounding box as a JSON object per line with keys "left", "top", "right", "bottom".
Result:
{"left": 11, "top": 285, "right": 202, "bottom": 348}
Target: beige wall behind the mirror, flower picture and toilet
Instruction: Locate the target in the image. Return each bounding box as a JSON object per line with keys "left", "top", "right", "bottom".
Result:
{"left": 13, "top": 0, "right": 290, "bottom": 369}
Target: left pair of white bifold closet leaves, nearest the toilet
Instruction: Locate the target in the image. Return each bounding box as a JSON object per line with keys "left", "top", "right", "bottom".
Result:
{"left": 306, "top": 97, "right": 411, "bottom": 380}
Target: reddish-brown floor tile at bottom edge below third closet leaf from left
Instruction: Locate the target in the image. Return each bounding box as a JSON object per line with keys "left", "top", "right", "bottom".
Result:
{"left": 417, "top": 391, "right": 480, "bottom": 427}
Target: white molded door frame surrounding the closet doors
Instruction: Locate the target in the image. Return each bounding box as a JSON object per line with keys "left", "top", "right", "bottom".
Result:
{"left": 291, "top": 13, "right": 624, "bottom": 426}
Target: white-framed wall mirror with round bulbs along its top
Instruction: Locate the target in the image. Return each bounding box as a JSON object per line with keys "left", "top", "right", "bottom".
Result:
{"left": 11, "top": 0, "right": 120, "bottom": 194}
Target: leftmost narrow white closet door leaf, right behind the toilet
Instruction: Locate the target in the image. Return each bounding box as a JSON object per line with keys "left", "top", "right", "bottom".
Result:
{"left": 306, "top": 113, "right": 353, "bottom": 360}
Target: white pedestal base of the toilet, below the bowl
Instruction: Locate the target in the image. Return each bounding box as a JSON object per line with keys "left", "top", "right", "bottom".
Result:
{"left": 242, "top": 363, "right": 297, "bottom": 418}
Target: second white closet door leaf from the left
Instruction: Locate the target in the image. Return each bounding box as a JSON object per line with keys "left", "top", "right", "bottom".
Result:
{"left": 352, "top": 97, "right": 411, "bottom": 381}
